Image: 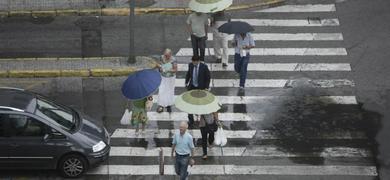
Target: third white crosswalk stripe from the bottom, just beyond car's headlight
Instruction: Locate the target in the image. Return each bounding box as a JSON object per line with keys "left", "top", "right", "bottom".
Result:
{"left": 111, "top": 128, "right": 367, "bottom": 140}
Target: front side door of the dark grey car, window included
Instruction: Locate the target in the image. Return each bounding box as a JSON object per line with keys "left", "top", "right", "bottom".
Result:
{"left": 8, "top": 114, "right": 58, "bottom": 169}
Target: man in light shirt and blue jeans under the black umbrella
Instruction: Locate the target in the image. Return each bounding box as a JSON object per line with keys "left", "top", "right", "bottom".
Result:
{"left": 233, "top": 32, "right": 255, "bottom": 89}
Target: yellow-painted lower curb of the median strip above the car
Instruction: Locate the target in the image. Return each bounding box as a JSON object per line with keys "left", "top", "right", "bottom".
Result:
{"left": 0, "top": 67, "right": 137, "bottom": 78}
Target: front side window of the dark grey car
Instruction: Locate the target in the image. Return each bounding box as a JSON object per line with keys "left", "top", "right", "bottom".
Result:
{"left": 8, "top": 114, "right": 46, "bottom": 137}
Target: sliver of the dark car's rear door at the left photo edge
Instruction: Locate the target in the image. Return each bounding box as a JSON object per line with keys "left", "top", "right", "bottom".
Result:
{"left": 0, "top": 114, "right": 9, "bottom": 168}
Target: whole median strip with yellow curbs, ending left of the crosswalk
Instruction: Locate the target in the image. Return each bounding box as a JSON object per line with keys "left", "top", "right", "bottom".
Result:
{"left": 0, "top": 57, "right": 155, "bottom": 78}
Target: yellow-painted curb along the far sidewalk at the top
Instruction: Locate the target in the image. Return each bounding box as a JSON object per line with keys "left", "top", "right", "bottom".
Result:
{"left": 0, "top": 0, "right": 285, "bottom": 17}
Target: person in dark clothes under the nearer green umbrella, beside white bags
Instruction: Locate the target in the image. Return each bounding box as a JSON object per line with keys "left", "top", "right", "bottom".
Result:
{"left": 199, "top": 112, "right": 218, "bottom": 160}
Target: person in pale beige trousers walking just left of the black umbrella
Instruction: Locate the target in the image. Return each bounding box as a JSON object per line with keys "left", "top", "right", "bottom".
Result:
{"left": 211, "top": 10, "right": 230, "bottom": 67}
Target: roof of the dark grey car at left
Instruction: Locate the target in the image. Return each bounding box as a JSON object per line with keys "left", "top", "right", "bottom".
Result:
{"left": 0, "top": 87, "right": 36, "bottom": 111}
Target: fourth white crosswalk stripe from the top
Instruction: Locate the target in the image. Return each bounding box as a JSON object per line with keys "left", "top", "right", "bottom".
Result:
{"left": 176, "top": 48, "right": 348, "bottom": 57}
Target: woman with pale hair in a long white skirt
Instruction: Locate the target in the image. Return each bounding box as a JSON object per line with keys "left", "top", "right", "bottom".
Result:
{"left": 157, "top": 49, "right": 177, "bottom": 113}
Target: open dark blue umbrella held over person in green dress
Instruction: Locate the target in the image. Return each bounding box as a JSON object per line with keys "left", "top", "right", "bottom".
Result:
{"left": 122, "top": 69, "right": 161, "bottom": 100}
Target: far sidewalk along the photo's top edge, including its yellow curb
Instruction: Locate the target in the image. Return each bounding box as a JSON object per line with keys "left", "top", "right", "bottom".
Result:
{"left": 0, "top": 0, "right": 284, "bottom": 16}
